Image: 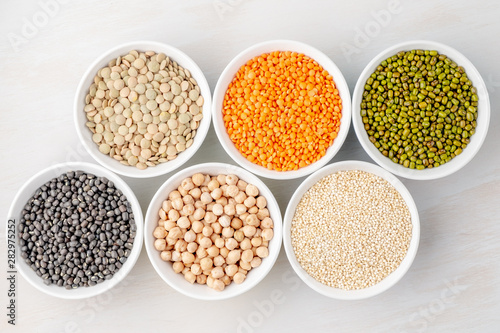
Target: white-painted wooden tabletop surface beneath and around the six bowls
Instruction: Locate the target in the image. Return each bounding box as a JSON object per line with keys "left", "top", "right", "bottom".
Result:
{"left": 0, "top": 0, "right": 500, "bottom": 333}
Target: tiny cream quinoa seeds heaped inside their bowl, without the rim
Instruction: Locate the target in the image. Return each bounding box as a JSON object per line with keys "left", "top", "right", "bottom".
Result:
{"left": 291, "top": 170, "right": 412, "bottom": 290}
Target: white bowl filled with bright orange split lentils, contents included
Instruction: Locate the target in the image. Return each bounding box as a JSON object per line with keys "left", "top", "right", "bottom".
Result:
{"left": 212, "top": 40, "right": 351, "bottom": 179}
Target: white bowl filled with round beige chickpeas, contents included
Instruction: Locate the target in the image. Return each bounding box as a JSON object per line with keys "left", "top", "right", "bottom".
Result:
{"left": 144, "top": 163, "right": 282, "bottom": 300}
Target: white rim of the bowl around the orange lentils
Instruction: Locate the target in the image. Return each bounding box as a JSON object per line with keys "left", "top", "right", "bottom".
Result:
{"left": 212, "top": 40, "right": 351, "bottom": 179}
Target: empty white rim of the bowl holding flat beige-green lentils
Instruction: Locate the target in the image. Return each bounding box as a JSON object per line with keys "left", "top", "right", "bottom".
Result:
{"left": 74, "top": 41, "right": 212, "bottom": 178}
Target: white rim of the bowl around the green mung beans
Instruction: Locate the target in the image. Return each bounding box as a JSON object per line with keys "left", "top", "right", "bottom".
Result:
{"left": 352, "top": 40, "right": 490, "bottom": 180}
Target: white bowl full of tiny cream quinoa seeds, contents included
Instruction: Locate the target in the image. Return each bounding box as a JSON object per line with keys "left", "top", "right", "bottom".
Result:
{"left": 283, "top": 161, "right": 420, "bottom": 300}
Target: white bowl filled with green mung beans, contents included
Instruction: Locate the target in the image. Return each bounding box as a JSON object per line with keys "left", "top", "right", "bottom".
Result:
{"left": 352, "top": 41, "right": 490, "bottom": 180}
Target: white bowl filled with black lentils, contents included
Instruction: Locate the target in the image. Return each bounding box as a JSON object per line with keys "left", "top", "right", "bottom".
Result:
{"left": 9, "top": 162, "right": 143, "bottom": 299}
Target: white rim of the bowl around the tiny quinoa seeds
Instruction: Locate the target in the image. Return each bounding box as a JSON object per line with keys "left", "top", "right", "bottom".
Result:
{"left": 283, "top": 161, "right": 420, "bottom": 300}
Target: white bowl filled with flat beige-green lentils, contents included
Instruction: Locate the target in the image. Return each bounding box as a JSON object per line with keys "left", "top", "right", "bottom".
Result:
{"left": 74, "top": 41, "right": 211, "bottom": 178}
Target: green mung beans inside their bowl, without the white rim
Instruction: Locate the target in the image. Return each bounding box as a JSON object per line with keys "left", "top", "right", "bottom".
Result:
{"left": 360, "top": 50, "right": 478, "bottom": 170}
